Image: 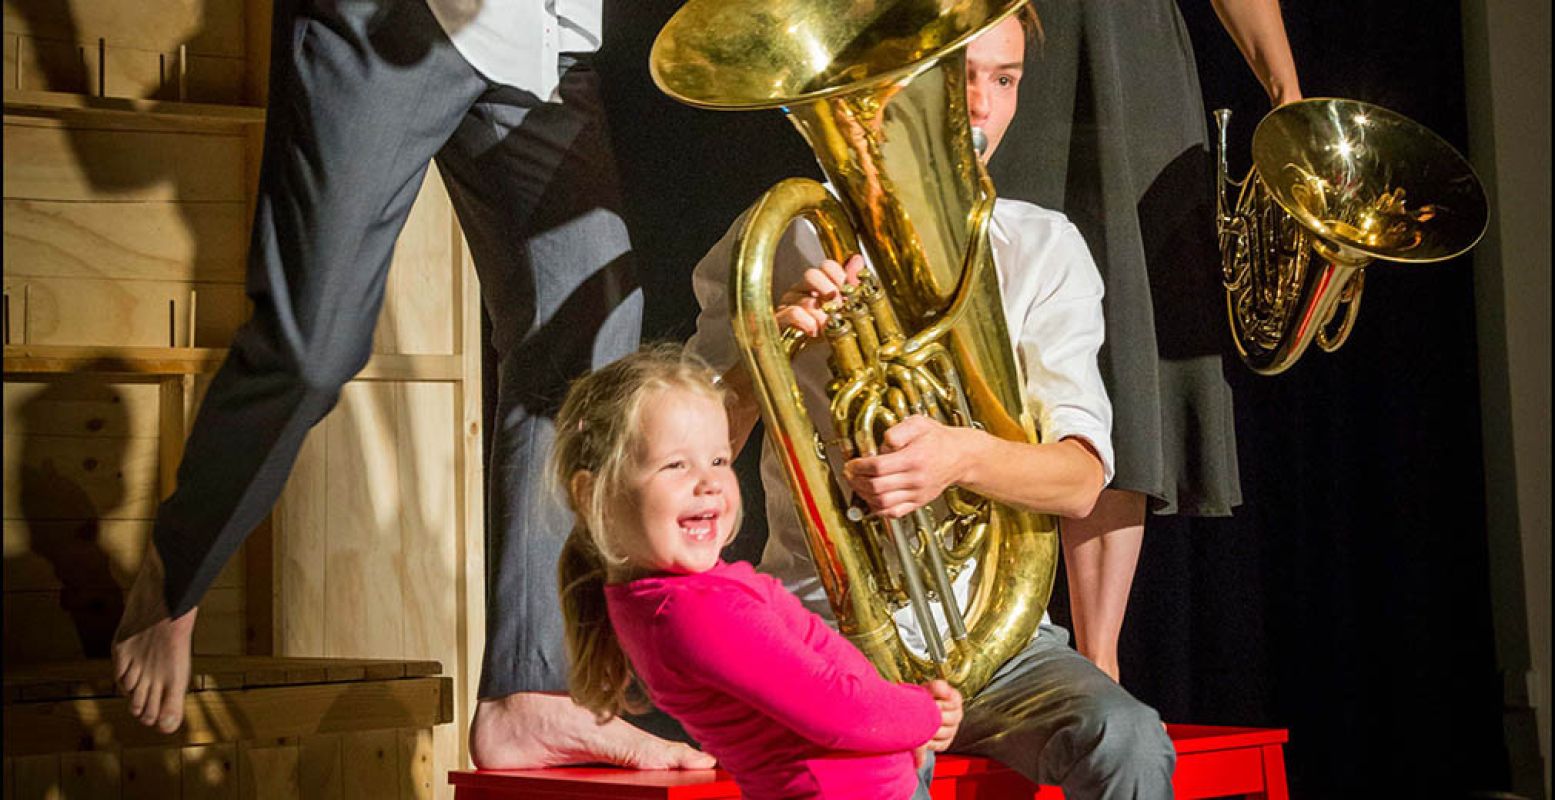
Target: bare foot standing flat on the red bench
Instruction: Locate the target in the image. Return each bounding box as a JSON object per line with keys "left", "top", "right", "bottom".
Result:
{"left": 470, "top": 693, "right": 717, "bottom": 769}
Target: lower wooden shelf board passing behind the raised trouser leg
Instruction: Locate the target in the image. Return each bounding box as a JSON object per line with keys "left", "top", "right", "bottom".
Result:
{"left": 5, "top": 344, "right": 465, "bottom": 383}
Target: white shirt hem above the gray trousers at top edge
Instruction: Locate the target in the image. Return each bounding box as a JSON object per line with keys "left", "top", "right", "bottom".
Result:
{"left": 426, "top": 0, "right": 603, "bottom": 100}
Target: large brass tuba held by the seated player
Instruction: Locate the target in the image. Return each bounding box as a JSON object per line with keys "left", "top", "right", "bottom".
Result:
{"left": 652, "top": 0, "right": 1057, "bottom": 693}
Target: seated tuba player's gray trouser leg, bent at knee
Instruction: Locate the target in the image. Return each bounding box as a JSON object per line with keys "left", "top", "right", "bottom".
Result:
{"left": 950, "top": 626, "right": 1177, "bottom": 800}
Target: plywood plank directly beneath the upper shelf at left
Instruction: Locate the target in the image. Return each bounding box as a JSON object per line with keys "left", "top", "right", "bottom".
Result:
{"left": 5, "top": 120, "right": 247, "bottom": 202}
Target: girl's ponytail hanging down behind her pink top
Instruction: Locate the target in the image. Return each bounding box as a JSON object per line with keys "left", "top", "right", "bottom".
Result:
{"left": 557, "top": 525, "right": 648, "bottom": 722}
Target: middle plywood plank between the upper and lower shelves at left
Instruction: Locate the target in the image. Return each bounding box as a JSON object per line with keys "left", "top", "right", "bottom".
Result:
{"left": 5, "top": 199, "right": 249, "bottom": 283}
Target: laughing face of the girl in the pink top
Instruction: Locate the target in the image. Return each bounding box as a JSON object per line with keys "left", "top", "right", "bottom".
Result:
{"left": 606, "top": 388, "right": 740, "bottom": 573}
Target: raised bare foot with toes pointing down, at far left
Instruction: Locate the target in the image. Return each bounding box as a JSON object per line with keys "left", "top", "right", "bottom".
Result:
{"left": 114, "top": 543, "right": 199, "bottom": 733}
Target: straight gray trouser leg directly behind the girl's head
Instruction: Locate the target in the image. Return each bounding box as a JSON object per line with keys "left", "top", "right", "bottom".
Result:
{"left": 437, "top": 56, "right": 642, "bottom": 699}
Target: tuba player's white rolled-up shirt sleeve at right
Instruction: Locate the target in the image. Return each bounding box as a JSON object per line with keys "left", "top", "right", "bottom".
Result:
{"left": 1001, "top": 215, "right": 1113, "bottom": 484}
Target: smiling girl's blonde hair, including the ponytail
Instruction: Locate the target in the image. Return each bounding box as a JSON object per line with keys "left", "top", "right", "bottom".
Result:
{"left": 550, "top": 344, "right": 725, "bottom": 722}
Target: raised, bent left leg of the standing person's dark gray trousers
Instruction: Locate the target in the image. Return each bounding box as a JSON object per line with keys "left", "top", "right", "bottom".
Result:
{"left": 154, "top": 0, "right": 485, "bottom": 615}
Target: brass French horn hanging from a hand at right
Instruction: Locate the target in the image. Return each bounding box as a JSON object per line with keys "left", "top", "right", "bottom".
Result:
{"left": 1214, "top": 98, "right": 1488, "bottom": 375}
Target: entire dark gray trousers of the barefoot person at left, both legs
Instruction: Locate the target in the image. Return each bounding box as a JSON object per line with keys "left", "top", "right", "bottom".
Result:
{"left": 154, "top": 0, "right": 642, "bottom": 697}
